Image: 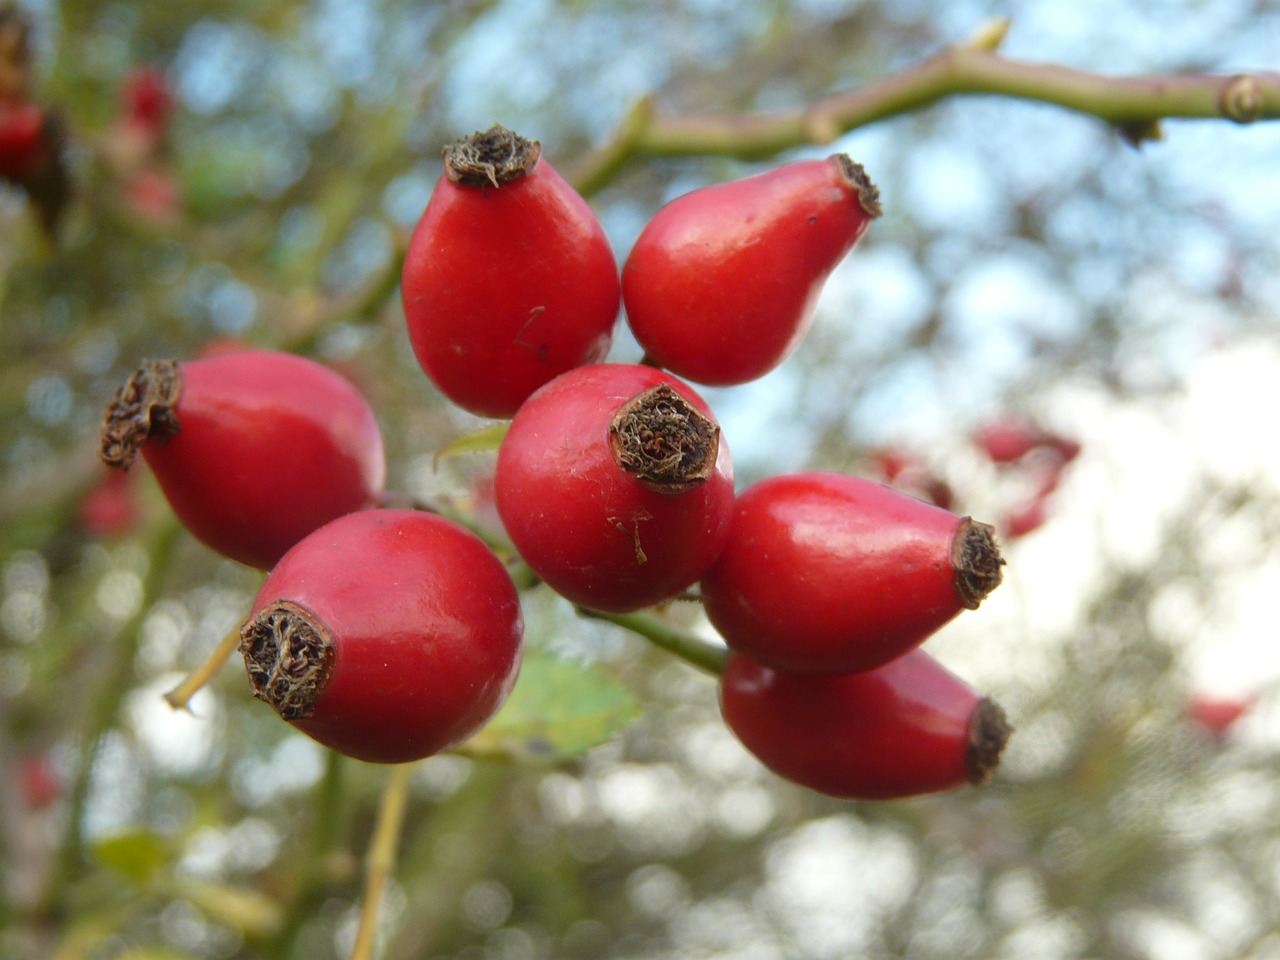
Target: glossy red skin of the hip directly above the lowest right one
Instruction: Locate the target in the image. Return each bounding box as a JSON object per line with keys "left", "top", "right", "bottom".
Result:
{"left": 701, "top": 472, "right": 964, "bottom": 673}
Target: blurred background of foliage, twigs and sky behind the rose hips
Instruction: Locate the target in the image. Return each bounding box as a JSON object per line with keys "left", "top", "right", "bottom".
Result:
{"left": 0, "top": 0, "right": 1280, "bottom": 960}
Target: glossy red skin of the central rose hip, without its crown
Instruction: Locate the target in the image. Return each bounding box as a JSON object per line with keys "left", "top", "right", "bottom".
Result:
{"left": 494, "top": 364, "right": 733, "bottom": 613}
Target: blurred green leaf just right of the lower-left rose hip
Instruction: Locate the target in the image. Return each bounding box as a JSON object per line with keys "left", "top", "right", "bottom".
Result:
{"left": 457, "top": 654, "right": 640, "bottom": 763}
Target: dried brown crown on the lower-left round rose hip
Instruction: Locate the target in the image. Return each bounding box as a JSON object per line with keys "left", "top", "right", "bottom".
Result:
{"left": 239, "top": 600, "right": 334, "bottom": 721}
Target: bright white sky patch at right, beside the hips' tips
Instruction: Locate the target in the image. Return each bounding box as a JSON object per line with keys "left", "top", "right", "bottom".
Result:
{"left": 934, "top": 338, "right": 1280, "bottom": 742}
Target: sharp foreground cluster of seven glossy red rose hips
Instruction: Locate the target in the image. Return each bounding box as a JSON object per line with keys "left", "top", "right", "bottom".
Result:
{"left": 102, "top": 127, "right": 1009, "bottom": 799}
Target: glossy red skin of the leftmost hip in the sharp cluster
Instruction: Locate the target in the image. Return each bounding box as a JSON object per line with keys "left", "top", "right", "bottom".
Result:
{"left": 142, "top": 351, "right": 387, "bottom": 570}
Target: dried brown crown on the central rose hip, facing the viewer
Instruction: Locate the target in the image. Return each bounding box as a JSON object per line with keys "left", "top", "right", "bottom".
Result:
{"left": 609, "top": 384, "right": 719, "bottom": 494}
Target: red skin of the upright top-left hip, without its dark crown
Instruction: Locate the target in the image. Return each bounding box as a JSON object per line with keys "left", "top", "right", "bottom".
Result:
{"left": 401, "top": 159, "right": 620, "bottom": 419}
